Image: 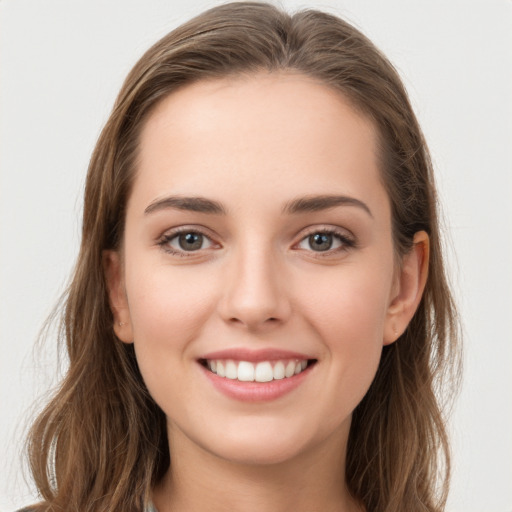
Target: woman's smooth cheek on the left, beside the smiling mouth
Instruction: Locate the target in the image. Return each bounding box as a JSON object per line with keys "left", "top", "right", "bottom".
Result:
{"left": 126, "top": 260, "right": 220, "bottom": 413}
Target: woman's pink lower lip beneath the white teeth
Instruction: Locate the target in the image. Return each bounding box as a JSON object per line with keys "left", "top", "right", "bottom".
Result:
{"left": 200, "top": 364, "right": 313, "bottom": 402}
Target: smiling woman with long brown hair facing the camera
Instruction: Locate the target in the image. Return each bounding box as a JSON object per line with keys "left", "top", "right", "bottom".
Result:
{"left": 23, "top": 3, "right": 457, "bottom": 512}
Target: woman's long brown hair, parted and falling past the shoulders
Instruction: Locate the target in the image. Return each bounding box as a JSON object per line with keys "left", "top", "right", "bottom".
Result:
{"left": 29, "top": 2, "right": 459, "bottom": 512}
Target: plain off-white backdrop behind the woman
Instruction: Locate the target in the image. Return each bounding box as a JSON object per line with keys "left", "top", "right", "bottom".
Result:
{"left": 0, "top": 0, "right": 512, "bottom": 512}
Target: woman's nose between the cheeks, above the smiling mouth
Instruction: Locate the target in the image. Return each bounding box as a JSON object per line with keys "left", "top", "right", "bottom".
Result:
{"left": 219, "top": 247, "right": 291, "bottom": 331}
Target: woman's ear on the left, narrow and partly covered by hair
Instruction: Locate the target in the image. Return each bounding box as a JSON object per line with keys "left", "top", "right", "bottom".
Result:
{"left": 102, "top": 250, "right": 133, "bottom": 343}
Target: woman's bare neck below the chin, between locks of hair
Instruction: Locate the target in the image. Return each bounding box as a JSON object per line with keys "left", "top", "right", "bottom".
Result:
{"left": 154, "top": 424, "right": 362, "bottom": 512}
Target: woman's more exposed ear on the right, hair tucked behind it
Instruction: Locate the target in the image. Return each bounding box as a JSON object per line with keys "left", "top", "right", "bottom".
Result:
{"left": 384, "top": 231, "right": 430, "bottom": 345}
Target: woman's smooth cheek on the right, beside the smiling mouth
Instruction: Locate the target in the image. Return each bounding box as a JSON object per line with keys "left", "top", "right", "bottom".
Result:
{"left": 294, "top": 267, "right": 391, "bottom": 404}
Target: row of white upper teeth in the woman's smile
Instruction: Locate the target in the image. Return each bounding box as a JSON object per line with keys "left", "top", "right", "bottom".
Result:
{"left": 206, "top": 359, "right": 308, "bottom": 382}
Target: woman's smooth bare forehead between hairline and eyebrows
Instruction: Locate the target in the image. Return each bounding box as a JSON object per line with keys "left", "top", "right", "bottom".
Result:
{"left": 130, "top": 73, "right": 382, "bottom": 214}
